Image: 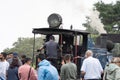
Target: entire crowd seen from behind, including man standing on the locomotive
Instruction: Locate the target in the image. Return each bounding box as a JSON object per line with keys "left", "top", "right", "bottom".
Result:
{"left": 0, "top": 37, "right": 120, "bottom": 80}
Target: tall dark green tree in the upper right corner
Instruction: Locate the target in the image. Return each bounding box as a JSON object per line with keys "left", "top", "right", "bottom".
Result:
{"left": 94, "top": 1, "right": 120, "bottom": 33}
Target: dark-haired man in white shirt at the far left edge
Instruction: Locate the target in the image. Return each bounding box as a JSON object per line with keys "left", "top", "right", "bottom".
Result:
{"left": 0, "top": 52, "right": 9, "bottom": 80}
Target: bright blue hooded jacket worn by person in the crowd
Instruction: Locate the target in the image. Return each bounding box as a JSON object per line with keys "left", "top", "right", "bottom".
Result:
{"left": 38, "top": 60, "right": 59, "bottom": 80}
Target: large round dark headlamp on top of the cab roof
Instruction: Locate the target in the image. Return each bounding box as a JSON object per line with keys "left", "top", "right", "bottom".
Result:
{"left": 48, "top": 13, "right": 62, "bottom": 28}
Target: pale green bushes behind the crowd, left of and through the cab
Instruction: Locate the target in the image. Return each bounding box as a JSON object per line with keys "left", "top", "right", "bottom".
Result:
{"left": 4, "top": 37, "right": 43, "bottom": 56}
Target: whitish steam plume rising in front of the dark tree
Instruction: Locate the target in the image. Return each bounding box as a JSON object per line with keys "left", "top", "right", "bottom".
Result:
{"left": 89, "top": 10, "right": 106, "bottom": 34}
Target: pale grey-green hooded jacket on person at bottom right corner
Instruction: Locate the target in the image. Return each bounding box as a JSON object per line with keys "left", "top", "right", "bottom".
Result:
{"left": 103, "top": 63, "right": 120, "bottom": 80}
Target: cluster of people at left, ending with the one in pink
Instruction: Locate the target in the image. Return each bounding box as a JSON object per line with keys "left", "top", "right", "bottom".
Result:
{"left": 0, "top": 52, "right": 37, "bottom": 80}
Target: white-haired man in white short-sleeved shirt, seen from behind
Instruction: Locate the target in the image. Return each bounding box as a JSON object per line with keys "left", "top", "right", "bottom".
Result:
{"left": 81, "top": 50, "right": 103, "bottom": 80}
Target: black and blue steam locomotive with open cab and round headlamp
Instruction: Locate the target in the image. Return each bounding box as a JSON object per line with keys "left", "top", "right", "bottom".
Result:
{"left": 32, "top": 13, "right": 113, "bottom": 75}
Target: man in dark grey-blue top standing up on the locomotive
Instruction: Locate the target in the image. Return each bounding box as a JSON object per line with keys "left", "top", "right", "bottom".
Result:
{"left": 37, "top": 36, "right": 60, "bottom": 67}
